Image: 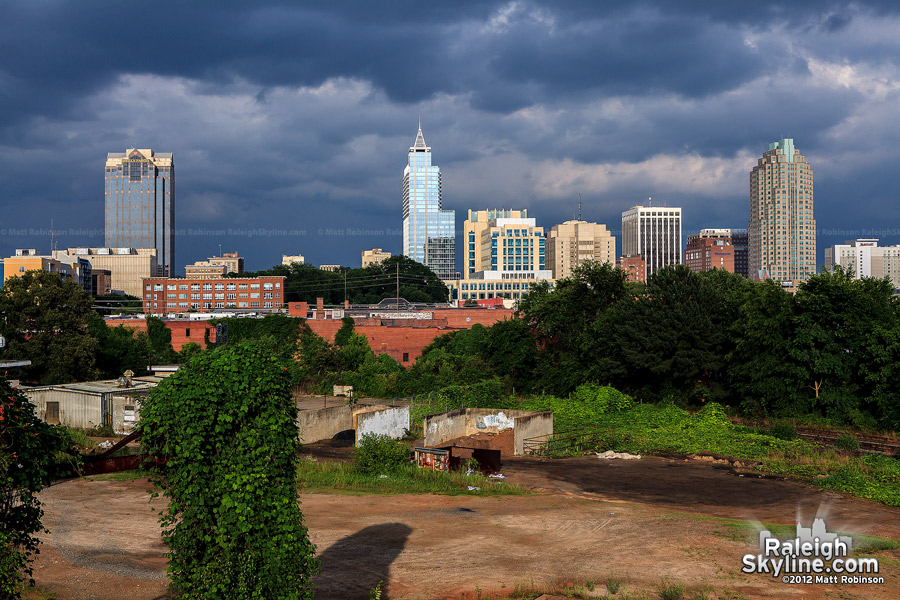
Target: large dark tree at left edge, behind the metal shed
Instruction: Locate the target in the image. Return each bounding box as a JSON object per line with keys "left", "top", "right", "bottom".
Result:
{"left": 0, "top": 271, "right": 98, "bottom": 384}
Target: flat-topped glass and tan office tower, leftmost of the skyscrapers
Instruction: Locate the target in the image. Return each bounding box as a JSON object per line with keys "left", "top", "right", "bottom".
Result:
{"left": 106, "top": 148, "right": 175, "bottom": 277}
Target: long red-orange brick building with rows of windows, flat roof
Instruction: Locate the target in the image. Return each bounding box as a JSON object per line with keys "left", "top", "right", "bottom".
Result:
{"left": 141, "top": 275, "right": 285, "bottom": 314}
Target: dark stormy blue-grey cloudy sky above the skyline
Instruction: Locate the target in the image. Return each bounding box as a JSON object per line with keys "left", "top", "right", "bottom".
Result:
{"left": 0, "top": 0, "right": 900, "bottom": 273}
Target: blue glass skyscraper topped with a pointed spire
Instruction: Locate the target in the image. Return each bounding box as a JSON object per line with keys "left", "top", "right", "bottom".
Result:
{"left": 403, "top": 123, "right": 456, "bottom": 280}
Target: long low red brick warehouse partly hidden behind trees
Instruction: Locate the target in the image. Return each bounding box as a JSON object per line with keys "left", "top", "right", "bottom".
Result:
{"left": 106, "top": 302, "right": 513, "bottom": 366}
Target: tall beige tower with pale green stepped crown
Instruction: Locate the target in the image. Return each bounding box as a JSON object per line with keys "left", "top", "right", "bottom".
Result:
{"left": 748, "top": 138, "right": 816, "bottom": 290}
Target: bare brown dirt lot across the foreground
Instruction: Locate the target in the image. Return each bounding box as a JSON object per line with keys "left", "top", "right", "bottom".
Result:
{"left": 29, "top": 449, "right": 900, "bottom": 599}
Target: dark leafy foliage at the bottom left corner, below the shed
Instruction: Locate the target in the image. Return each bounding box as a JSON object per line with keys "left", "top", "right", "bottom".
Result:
{"left": 0, "top": 377, "right": 72, "bottom": 598}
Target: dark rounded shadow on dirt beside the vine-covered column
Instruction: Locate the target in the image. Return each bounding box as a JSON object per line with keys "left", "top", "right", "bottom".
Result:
{"left": 313, "top": 523, "right": 412, "bottom": 600}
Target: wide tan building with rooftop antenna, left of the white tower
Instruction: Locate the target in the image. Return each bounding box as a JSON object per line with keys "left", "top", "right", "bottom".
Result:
{"left": 547, "top": 221, "right": 616, "bottom": 279}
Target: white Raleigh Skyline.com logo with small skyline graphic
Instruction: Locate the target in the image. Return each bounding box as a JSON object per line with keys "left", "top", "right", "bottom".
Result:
{"left": 741, "top": 519, "right": 884, "bottom": 584}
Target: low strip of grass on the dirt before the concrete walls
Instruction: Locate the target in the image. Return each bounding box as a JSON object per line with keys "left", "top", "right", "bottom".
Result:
{"left": 297, "top": 457, "right": 529, "bottom": 496}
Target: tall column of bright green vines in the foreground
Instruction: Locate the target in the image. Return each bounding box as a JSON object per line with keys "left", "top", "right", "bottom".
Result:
{"left": 139, "top": 342, "right": 317, "bottom": 599}
